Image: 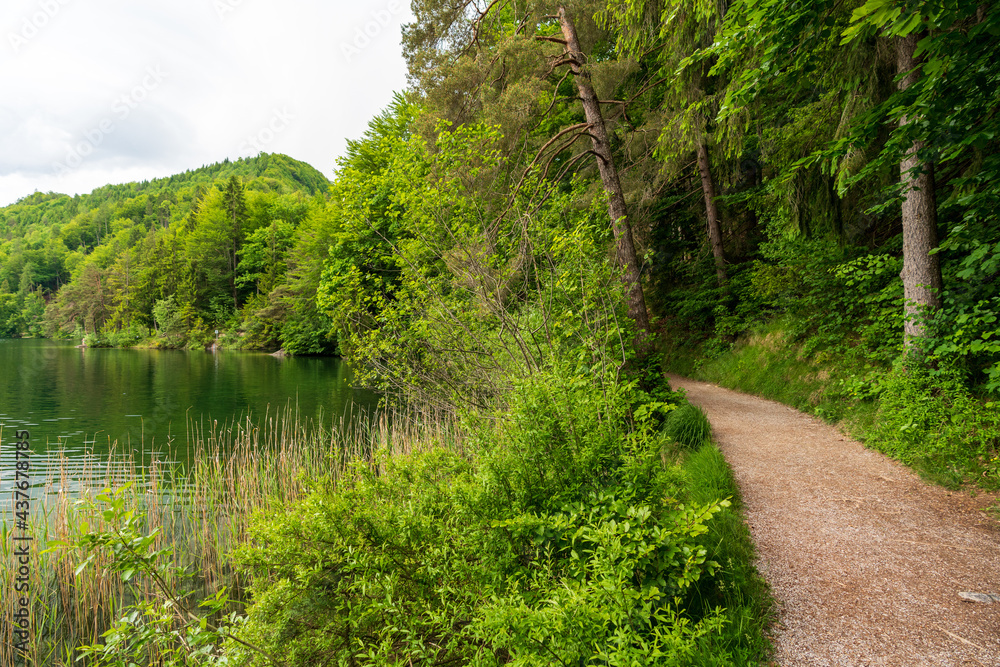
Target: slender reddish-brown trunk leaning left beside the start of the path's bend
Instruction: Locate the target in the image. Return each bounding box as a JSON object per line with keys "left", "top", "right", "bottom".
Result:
{"left": 559, "top": 7, "right": 649, "bottom": 344}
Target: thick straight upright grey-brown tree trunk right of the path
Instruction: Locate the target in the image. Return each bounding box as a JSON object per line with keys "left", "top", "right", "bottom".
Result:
{"left": 896, "top": 35, "right": 942, "bottom": 349}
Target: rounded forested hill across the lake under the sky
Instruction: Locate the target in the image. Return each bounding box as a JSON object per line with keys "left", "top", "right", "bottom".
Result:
{"left": 0, "top": 153, "right": 331, "bottom": 352}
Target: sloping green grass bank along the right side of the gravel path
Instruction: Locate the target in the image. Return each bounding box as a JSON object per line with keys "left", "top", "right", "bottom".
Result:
{"left": 669, "top": 321, "right": 1000, "bottom": 490}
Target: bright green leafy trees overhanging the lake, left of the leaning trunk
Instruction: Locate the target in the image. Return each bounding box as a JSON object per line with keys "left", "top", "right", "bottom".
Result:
{"left": 317, "top": 110, "right": 629, "bottom": 409}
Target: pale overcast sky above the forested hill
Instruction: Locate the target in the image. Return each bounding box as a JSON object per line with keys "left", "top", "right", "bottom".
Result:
{"left": 0, "top": 0, "right": 411, "bottom": 206}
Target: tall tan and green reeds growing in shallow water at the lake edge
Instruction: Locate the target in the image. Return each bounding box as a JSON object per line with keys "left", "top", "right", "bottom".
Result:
{"left": 0, "top": 407, "right": 463, "bottom": 667}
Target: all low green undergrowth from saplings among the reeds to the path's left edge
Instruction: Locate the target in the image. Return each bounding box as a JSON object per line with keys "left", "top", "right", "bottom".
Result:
{"left": 33, "top": 374, "right": 771, "bottom": 667}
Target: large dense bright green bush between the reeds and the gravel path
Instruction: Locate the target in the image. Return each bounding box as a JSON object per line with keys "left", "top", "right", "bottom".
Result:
{"left": 233, "top": 376, "right": 761, "bottom": 666}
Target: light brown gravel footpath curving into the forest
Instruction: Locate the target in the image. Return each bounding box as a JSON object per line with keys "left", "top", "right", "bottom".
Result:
{"left": 670, "top": 377, "right": 1000, "bottom": 667}
